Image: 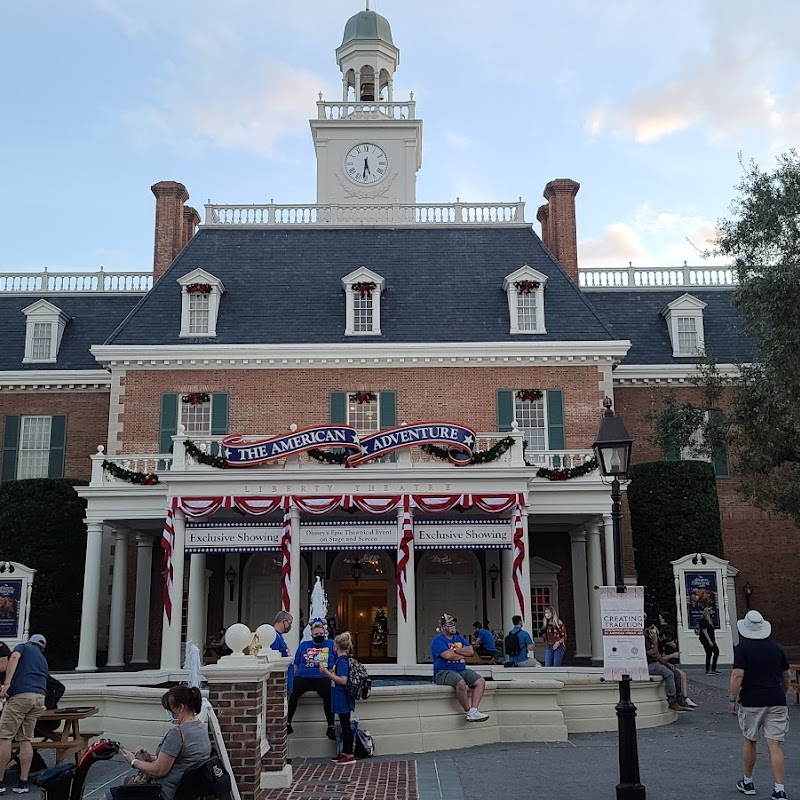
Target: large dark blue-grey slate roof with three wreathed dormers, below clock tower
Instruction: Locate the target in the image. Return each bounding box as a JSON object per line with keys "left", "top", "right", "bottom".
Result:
{"left": 106, "top": 228, "right": 615, "bottom": 345}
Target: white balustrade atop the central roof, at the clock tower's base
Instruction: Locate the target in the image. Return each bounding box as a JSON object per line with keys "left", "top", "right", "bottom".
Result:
{"left": 204, "top": 200, "right": 525, "bottom": 227}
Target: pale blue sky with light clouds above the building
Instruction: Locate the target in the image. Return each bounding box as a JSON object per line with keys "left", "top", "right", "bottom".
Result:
{"left": 0, "top": 0, "right": 800, "bottom": 272}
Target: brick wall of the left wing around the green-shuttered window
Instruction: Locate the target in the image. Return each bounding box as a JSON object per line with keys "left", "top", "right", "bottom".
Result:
{"left": 0, "top": 391, "right": 108, "bottom": 480}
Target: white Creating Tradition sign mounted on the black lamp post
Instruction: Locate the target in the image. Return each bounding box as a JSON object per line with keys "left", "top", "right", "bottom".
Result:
{"left": 597, "top": 586, "right": 650, "bottom": 681}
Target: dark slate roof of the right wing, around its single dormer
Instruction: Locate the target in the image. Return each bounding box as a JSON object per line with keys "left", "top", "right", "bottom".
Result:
{"left": 585, "top": 287, "right": 753, "bottom": 365}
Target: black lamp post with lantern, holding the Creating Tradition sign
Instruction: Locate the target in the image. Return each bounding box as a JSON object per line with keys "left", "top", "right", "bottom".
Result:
{"left": 592, "top": 397, "right": 646, "bottom": 800}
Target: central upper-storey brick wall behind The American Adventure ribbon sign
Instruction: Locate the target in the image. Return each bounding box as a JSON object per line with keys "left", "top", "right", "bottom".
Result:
{"left": 120, "top": 365, "right": 603, "bottom": 453}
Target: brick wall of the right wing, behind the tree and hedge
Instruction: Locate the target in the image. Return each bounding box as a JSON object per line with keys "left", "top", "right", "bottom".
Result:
{"left": 614, "top": 387, "right": 800, "bottom": 645}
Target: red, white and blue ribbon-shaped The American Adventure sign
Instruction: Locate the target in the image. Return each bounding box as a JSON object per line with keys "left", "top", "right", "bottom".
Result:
{"left": 222, "top": 422, "right": 475, "bottom": 467}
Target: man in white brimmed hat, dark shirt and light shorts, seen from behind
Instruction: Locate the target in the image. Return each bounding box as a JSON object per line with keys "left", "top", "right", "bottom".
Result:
{"left": 728, "top": 610, "right": 790, "bottom": 800}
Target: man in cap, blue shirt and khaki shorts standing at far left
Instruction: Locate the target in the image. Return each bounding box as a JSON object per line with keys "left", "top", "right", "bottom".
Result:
{"left": 0, "top": 633, "right": 48, "bottom": 794}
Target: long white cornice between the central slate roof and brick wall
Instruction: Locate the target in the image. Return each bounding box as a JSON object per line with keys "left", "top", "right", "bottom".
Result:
{"left": 91, "top": 339, "right": 631, "bottom": 370}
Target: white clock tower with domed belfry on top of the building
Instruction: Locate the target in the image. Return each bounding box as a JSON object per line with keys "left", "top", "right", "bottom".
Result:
{"left": 311, "top": 4, "right": 422, "bottom": 206}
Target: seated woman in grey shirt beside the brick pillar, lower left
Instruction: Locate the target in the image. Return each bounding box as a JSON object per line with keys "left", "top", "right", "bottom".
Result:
{"left": 112, "top": 686, "right": 211, "bottom": 800}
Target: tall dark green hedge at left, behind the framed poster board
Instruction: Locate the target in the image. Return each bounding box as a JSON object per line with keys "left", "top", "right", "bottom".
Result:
{"left": 0, "top": 478, "right": 86, "bottom": 670}
